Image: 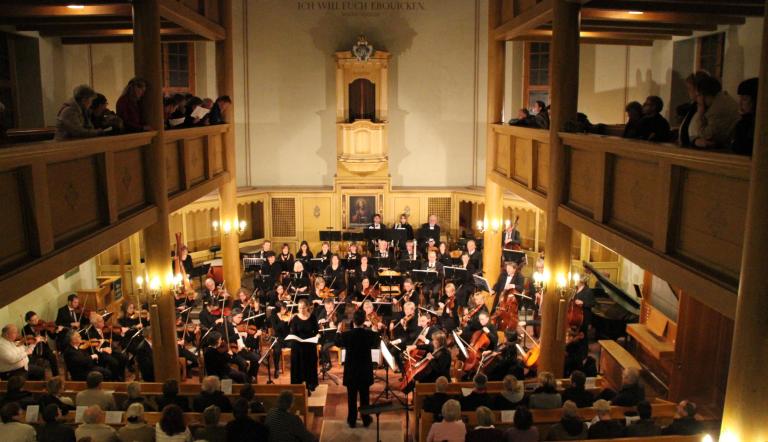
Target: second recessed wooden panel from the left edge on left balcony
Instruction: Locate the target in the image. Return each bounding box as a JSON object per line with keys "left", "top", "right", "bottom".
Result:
{"left": 48, "top": 157, "right": 104, "bottom": 247}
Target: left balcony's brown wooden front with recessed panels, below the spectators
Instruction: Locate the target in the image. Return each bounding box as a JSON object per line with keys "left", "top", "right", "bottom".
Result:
{"left": 0, "top": 125, "right": 229, "bottom": 304}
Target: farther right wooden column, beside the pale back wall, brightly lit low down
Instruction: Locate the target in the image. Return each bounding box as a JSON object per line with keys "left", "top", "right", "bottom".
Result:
{"left": 482, "top": 0, "right": 505, "bottom": 305}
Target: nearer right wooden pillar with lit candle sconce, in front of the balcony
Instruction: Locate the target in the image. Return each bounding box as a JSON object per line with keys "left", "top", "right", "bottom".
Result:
{"left": 539, "top": 0, "right": 579, "bottom": 377}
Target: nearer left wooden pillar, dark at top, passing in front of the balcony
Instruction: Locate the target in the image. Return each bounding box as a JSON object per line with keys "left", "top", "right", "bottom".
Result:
{"left": 133, "top": 0, "right": 180, "bottom": 381}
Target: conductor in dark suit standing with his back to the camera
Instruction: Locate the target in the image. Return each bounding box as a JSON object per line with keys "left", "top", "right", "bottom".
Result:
{"left": 339, "top": 310, "right": 379, "bottom": 428}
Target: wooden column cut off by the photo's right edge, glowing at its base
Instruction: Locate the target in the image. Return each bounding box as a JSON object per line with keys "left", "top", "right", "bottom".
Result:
{"left": 720, "top": 2, "right": 768, "bottom": 441}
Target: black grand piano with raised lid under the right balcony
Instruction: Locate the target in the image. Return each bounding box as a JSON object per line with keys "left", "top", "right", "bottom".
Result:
{"left": 583, "top": 261, "right": 641, "bottom": 340}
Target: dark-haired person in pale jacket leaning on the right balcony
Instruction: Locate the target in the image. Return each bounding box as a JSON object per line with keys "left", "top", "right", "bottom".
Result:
{"left": 688, "top": 73, "right": 739, "bottom": 149}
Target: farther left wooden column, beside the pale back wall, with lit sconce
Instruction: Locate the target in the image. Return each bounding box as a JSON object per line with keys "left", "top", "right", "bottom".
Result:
{"left": 216, "top": 0, "right": 242, "bottom": 294}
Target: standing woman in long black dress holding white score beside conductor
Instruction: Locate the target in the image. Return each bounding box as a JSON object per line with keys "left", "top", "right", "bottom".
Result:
{"left": 290, "top": 299, "right": 320, "bottom": 393}
